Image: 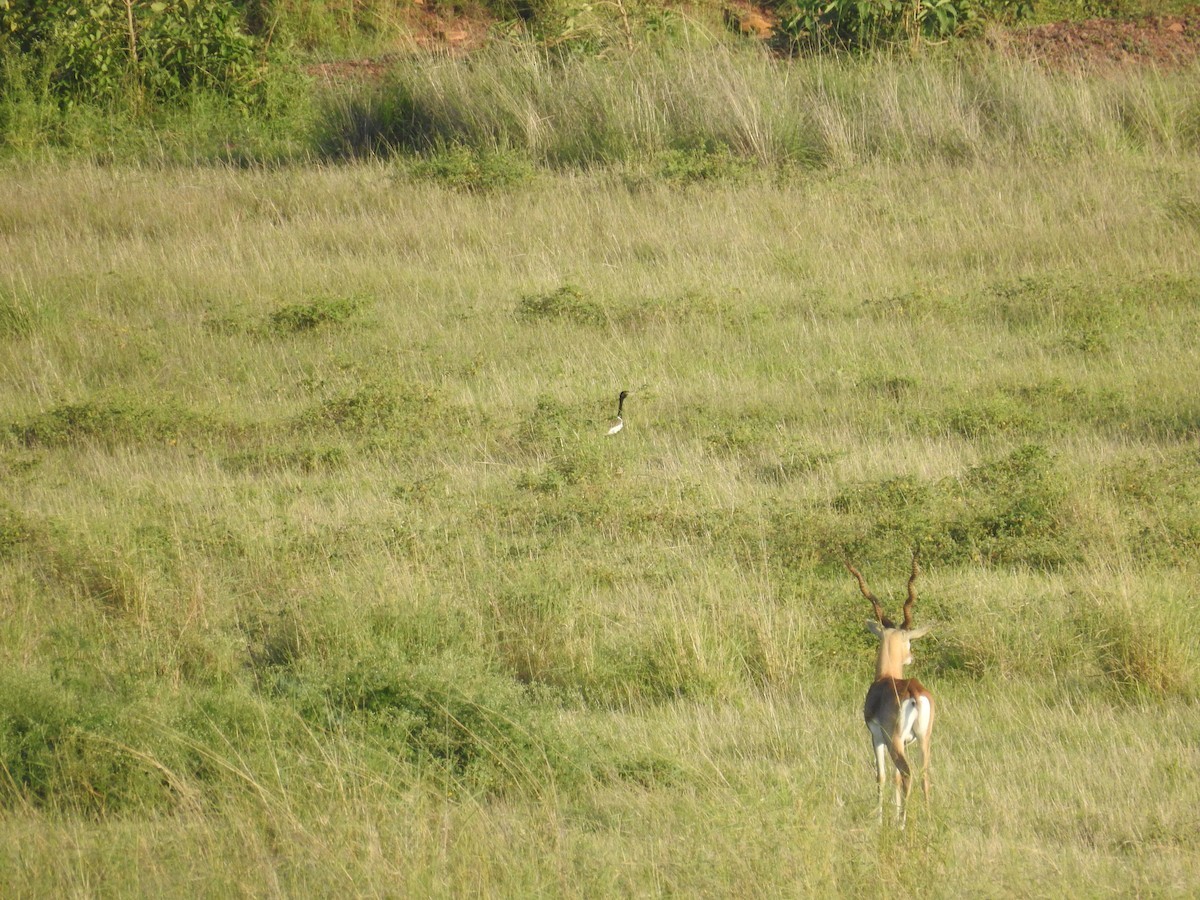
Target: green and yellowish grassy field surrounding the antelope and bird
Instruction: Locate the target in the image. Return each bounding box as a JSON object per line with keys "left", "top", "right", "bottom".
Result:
{"left": 0, "top": 47, "right": 1200, "bottom": 896}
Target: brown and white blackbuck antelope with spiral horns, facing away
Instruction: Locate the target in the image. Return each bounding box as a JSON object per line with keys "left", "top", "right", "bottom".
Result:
{"left": 846, "top": 553, "right": 934, "bottom": 827}
